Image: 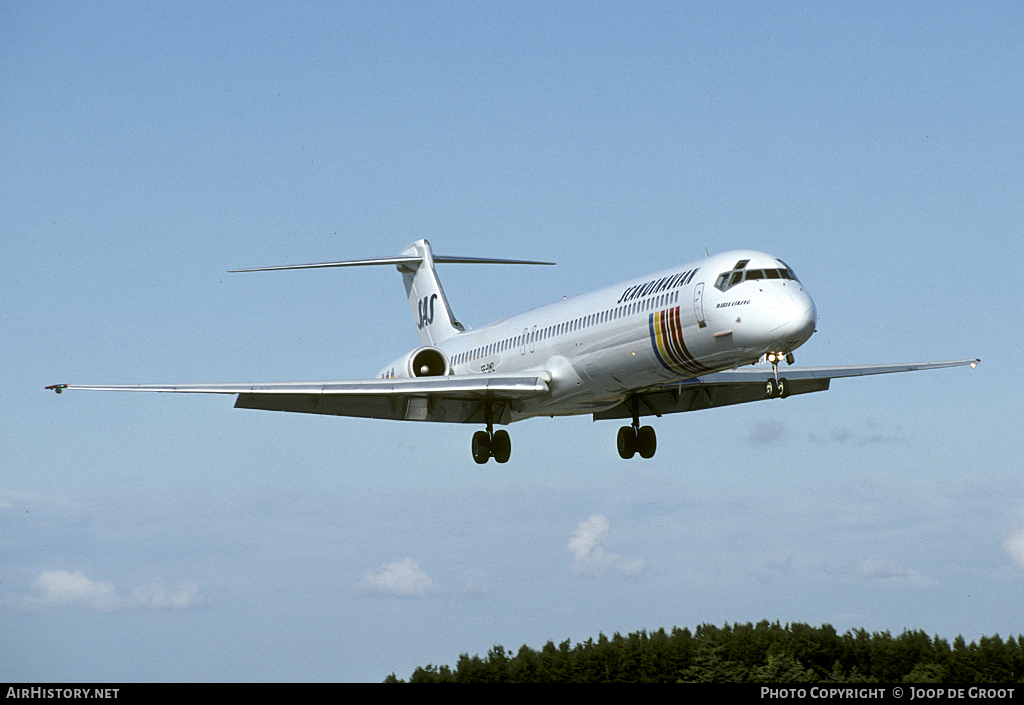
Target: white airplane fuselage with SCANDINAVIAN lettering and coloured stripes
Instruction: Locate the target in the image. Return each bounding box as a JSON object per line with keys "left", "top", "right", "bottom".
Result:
{"left": 379, "top": 250, "right": 816, "bottom": 420}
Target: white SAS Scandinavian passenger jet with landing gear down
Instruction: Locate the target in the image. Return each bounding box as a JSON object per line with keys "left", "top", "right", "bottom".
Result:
{"left": 46, "top": 240, "right": 980, "bottom": 464}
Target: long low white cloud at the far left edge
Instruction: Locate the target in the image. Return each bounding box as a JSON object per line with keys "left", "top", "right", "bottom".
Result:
{"left": 0, "top": 571, "right": 204, "bottom": 612}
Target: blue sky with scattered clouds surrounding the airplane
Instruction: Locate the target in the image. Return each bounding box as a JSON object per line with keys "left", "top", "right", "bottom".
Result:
{"left": 0, "top": 2, "right": 1024, "bottom": 681}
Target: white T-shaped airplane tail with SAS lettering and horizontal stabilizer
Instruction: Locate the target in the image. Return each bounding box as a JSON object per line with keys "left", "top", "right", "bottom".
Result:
{"left": 230, "top": 240, "right": 554, "bottom": 345}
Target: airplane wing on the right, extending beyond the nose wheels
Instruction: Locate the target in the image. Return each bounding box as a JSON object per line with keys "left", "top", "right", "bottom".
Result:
{"left": 594, "top": 359, "right": 981, "bottom": 421}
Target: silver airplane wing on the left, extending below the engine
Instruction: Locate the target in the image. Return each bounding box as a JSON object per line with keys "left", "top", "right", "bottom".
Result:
{"left": 46, "top": 373, "right": 549, "bottom": 424}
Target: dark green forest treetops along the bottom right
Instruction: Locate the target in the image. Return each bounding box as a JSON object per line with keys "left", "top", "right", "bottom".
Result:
{"left": 384, "top": 620, "right": 1024, "bottom": 683}
